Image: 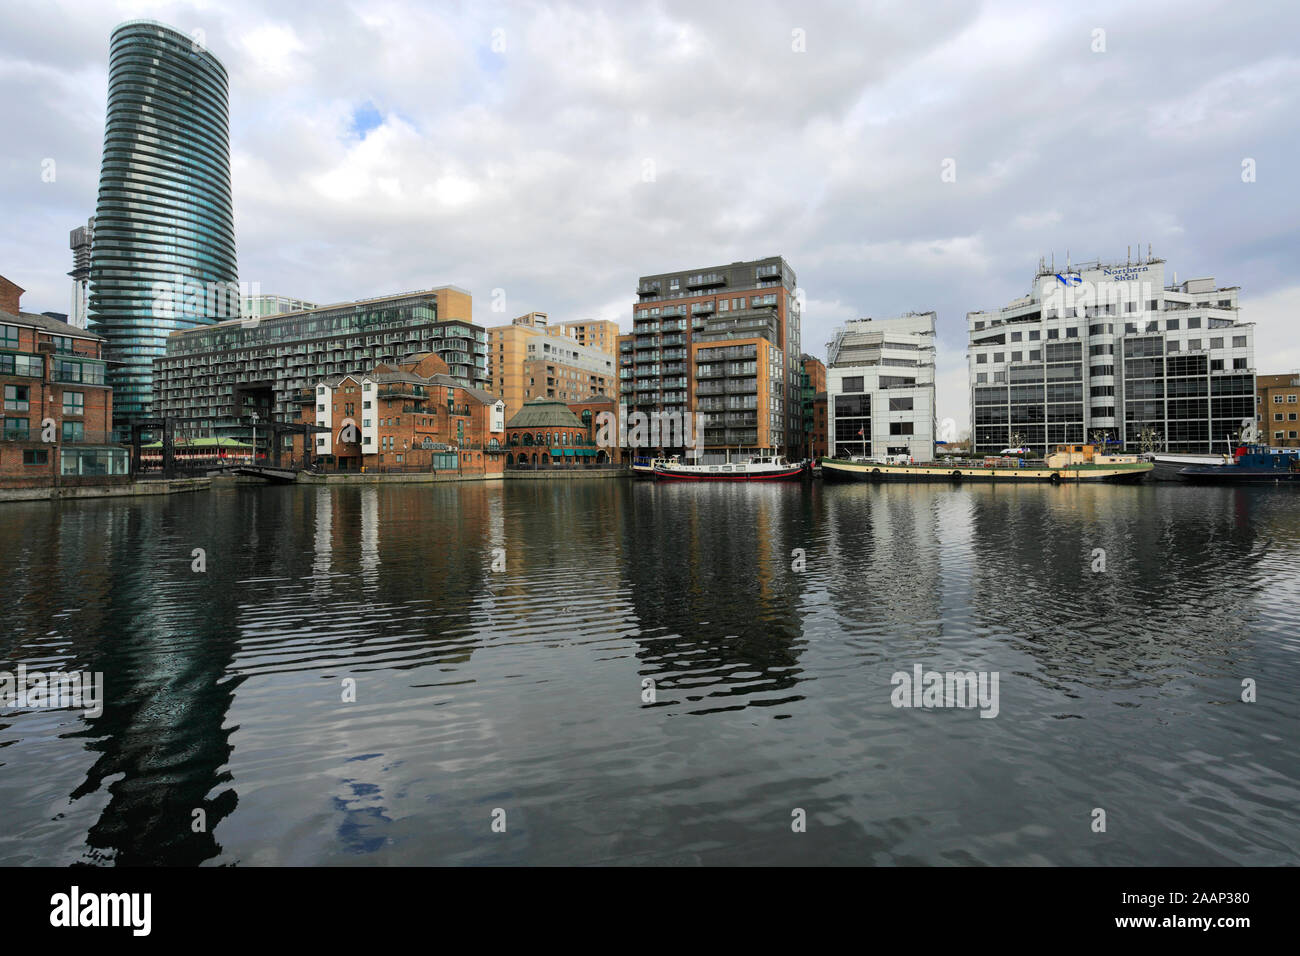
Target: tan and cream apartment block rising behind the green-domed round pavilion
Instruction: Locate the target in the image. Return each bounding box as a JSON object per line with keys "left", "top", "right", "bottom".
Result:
{"left": 488, "top": 312, "right": 619, "bottom": 416}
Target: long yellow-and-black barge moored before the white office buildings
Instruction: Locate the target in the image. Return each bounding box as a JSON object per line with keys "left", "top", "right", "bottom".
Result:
{"left": 819, "top": 445, "right": 1156, "bottom": 484}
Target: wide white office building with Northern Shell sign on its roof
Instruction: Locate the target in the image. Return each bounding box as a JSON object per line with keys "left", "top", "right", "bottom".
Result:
{"left": 967, "top": 255, "right": 1256, "bottom": 454}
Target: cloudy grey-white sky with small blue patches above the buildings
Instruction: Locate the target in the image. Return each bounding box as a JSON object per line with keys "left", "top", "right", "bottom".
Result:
{"left": 0, "top": 0, "right": 1300, "bottom": 428}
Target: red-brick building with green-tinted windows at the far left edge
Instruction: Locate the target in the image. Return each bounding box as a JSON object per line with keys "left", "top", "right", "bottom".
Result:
{"left": 0, "top": 276, "right": 130, "bottom": 488}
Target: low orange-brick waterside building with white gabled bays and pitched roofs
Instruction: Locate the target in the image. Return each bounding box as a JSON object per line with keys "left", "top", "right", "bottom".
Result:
{"left": 297, "top": 352, "right": 506, "bottom": 475}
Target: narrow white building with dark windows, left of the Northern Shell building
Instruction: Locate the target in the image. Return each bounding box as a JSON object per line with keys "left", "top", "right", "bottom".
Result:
{"left": 826, "top": 312, "right": 935, "bottom": 462}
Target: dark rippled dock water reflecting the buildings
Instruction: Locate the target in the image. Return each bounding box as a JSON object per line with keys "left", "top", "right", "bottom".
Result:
{"left": 0, "top": 480, "right": 1300, "bottom": 865}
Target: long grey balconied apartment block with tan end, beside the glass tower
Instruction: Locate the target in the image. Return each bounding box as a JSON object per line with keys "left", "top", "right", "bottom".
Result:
{"left": 155, "top": 286, "right": 489, "bottom": 436}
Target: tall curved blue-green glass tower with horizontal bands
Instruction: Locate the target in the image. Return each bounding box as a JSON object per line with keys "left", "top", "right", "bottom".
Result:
{"left": 90, "top": 20, "right": 239, "bottom": 438}
